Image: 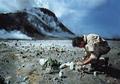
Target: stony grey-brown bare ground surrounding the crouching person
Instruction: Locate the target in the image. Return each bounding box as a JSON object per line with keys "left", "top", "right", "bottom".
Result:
{"left": 0, "top": 40, "right": 120, "bottom": 84}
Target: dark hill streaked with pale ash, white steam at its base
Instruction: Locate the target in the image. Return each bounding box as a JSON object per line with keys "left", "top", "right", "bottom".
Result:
{"left": 0, "top": 8, "right": 74, "bottom": 39}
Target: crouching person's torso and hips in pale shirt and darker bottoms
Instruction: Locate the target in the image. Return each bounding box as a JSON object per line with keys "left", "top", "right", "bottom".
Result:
{"left": 84, "top": 34, "right": 110, "bottom": 58}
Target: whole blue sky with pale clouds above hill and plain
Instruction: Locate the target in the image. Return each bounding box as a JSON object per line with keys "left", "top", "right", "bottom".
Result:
{"left": 0, "top": 0, "right": 120, "bottom": 38}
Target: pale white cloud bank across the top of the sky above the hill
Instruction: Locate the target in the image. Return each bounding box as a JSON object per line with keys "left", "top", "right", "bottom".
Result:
{"left": 0, "top": 0, "right": 106, "bottom": 17}
